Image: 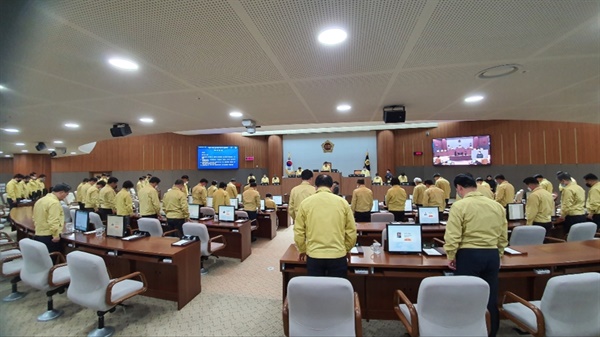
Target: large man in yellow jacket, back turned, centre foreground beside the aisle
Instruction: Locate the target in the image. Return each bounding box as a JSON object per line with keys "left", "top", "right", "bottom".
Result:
{"left": 294, "top": 174, "right": 356, "bottom": 278}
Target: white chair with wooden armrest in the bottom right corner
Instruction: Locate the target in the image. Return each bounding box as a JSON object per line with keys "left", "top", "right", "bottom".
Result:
{"left": 500, "top": 273, "right": 600, "bottom": 337}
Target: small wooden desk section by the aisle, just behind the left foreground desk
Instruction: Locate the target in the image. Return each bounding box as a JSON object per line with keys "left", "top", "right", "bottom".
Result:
{"left": 198, "top": 220, "right": 252, "bottom": 261}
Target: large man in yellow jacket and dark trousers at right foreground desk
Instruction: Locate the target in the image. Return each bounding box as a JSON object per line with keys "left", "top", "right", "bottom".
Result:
{"left": 444, "top": 174, "right": 508, "bottom": 336}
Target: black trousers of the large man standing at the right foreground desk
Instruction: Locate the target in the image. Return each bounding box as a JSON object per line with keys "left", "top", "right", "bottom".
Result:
{"left": 454, "top": 248, "right": 500, "bottom": 336}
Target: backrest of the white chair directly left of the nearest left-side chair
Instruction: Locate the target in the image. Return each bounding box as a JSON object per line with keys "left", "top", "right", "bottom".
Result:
{"left": 19, "top": 239, "right": 53, "bottom": 290}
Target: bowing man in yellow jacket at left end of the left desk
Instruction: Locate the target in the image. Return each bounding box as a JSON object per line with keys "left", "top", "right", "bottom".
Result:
{"left": 33, "top": 183, "right": 71, "bottom": 253}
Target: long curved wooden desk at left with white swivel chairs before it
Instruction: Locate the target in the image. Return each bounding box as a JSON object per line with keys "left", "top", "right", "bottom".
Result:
{"left": 10, "top": 207, "right": 202, "bottom": 309}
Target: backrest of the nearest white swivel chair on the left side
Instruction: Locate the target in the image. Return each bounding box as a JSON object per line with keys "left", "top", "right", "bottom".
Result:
{"left": 67, "top": 250, "right": 110, "bottom": 311}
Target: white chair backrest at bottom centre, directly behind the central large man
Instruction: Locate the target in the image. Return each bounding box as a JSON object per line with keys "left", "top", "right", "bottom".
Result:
{"left": 287, "top": 276, "right": 356, "bottom": 336}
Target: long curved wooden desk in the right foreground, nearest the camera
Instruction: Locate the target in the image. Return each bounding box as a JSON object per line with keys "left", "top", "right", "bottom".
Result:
{"left": 279, "top": 240, "right": 600, "bottom": 320}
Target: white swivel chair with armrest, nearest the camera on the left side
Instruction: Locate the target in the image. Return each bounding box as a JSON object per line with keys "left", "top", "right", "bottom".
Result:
{"left": 67, "top": 251, "right": 147, "bottom": 337}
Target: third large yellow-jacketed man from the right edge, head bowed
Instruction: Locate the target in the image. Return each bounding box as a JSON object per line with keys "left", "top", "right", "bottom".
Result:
{"left": 523, "top": 177, "right": 554, "bottom": 232}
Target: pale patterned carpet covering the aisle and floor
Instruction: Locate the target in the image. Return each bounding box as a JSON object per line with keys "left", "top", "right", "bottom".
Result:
{"left": 0, "top": 222, "right": 518, "bottom": 336}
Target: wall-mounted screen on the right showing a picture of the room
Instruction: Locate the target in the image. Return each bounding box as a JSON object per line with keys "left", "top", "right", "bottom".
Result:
{"left": 431, "top": 135, "right": 492, "bottom": 166}
